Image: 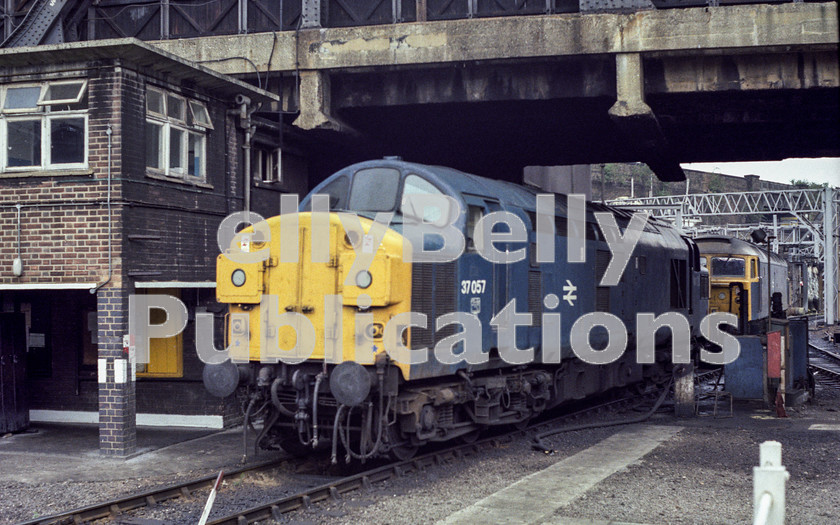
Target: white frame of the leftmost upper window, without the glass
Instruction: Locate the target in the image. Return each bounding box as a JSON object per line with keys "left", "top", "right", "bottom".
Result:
{"left": 0, "top": 79, "right": 90, "bottom": 173}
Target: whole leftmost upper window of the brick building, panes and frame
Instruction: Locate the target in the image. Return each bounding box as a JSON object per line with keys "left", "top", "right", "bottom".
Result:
{"left": 0, "top": 80, "right": 88, "bottom": 172}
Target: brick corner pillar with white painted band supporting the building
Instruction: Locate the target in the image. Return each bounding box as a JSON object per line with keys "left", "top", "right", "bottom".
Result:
{"left": 96, "top": 284, "right": 137, "bottom": 456}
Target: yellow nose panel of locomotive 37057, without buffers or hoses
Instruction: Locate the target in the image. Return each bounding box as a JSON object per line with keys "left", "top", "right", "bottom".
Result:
{"left": 216, "top": 212, "right": 411, "bottom": 377}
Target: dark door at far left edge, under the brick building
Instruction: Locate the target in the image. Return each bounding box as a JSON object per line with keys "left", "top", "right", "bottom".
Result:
{"left": 0, "top": 313, "right": 29, "bottom": 434}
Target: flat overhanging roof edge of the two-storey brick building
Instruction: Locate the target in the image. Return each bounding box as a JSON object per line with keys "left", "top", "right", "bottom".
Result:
{"left": 0, "top": 38, "right": 280, "bottom": 102}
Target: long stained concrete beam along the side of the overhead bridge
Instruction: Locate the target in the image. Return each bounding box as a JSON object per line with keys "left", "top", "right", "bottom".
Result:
{"left": 155, "top": 2, "right": 838, "bottom": 75}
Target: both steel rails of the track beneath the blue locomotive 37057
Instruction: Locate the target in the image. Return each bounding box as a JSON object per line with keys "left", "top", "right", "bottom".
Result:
{"left": 19, "top": 378, "right": 680, "bottom": 525}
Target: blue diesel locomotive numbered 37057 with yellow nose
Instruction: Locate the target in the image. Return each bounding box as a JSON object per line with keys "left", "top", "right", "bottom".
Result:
{"left": 205, "top": 159, "right": 709, "bottom": 459}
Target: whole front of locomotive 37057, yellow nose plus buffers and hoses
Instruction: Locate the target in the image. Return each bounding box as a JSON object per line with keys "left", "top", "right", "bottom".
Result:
{"left": 212, "top": 212, "right": 420, "bottom": 459}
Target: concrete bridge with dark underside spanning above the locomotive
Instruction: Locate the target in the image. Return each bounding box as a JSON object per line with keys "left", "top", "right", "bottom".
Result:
{"left": 154, "top": 2, "right": 840, "bottom": 180}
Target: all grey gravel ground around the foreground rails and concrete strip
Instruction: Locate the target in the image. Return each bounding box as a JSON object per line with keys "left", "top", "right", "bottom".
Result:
{"left": 0, "top": 398, "right": 840, "bottom": 525}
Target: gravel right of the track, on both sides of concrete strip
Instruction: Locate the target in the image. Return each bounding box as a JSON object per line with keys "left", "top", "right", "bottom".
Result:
{"left": 270, "top": 400, "right": 840, "bottom": 525}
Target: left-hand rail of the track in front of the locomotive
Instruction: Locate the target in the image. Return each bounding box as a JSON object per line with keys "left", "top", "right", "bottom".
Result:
{"left": 18, "top": 458, "right": 288, "bottom": 525}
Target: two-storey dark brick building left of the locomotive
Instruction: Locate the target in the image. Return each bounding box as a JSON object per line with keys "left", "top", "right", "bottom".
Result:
{"left": 0, "top": 39, "right": 307, "bottom": 455}
